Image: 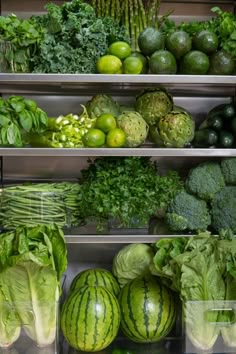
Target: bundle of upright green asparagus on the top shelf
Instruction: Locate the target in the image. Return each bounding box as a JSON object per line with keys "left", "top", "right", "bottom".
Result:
{"left": 92, "top": 0, "right": 161, "bottom": 50}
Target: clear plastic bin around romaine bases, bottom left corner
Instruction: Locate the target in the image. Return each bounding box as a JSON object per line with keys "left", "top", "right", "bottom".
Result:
{"left": 0, "top": 301, "right": 59, "bottom": 354}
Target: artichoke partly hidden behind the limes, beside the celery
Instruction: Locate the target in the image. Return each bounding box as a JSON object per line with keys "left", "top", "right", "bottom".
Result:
{"left": 86, "top": 94, "right": 120, "bottom": 118}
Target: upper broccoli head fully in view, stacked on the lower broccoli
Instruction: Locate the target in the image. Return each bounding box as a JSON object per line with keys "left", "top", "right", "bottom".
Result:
{"left": 185, "top": 162, "right": 225, "bottom": 201}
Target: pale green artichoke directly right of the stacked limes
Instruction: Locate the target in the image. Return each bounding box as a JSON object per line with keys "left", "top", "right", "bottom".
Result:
{"left": 117, "top": 111, "right": 148, "bottom": 147}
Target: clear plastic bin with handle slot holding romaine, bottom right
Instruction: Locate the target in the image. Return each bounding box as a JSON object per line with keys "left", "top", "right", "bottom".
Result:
{"left": 184, "top": 301, "right": 236, "bottom": 354}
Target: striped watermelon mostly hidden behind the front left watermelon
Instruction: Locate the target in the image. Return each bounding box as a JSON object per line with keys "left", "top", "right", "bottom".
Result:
{"left": 70, "top": 268, "right": 120, "bottom": 296}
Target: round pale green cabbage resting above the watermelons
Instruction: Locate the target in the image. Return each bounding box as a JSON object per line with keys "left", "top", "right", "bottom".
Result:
{"left": 112, "top": 243, "right": 154, "bottom": 287}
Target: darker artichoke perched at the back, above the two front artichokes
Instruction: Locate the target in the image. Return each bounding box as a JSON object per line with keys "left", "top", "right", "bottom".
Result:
{"left": 135, "top": 88, "right": 173, "bottom": 125}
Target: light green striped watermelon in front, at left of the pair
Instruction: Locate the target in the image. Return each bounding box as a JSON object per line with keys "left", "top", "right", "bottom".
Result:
{"left": 61, "top": 286, "right": 120, "bottom": 352}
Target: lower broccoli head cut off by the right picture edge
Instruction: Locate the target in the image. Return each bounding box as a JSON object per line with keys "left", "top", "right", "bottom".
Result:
{"left": 211, "top": 187, "right": 236, "bottom": 233}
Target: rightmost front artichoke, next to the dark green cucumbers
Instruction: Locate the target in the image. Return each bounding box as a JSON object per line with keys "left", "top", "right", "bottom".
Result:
{"left": 150, "top": 111, "right": 195, "bottom": 148}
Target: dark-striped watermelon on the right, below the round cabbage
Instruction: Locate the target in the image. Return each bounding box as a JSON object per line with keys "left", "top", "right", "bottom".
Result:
{"left": 119, "top": 275, "right": 176, "bottom": 343}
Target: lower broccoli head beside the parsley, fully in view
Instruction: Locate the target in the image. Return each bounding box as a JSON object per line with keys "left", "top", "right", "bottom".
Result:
{"left": 166, "top": 190, "right": 211, "bottom": 231}
